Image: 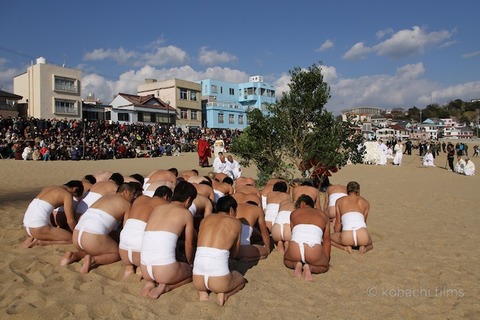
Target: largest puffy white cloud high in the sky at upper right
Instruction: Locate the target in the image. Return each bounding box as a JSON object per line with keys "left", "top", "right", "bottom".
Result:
{"left": 373, "top": 26, "right": 453, "bottom": 59}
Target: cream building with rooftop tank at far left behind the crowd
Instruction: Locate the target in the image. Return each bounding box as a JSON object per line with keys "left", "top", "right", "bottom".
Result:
{"left": 13, "top": 57, "right": 82, "bottom": 119}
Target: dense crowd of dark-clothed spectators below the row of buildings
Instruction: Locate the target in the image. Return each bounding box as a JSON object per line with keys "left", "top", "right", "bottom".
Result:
{"left": 0, "top": 116, "right": 240, "bottom": 160}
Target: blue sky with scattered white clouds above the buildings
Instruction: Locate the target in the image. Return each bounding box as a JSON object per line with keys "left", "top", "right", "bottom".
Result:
{"left": 0, "top": 0, "right": 480, "bottom": 114}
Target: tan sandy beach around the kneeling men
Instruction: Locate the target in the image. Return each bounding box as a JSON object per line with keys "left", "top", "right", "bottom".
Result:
{"left": 0, "top": 143, "right": 480, "bottom": 319}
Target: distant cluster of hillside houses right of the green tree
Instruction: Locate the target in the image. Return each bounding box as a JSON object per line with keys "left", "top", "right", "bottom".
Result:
{"left": 342, "top": 107, "right": 476, "bottom": 140}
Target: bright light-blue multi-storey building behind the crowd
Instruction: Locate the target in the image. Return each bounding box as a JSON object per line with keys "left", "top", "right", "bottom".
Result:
{"left": 199, "top": 76, "right": 276, "bottom": 130}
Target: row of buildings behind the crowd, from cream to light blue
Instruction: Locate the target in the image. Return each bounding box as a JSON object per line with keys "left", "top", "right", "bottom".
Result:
{"left": 0, "top": 58, "right": 276, "bottom": 130}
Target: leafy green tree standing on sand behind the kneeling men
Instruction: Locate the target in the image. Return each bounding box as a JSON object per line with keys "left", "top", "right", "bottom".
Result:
{"left": 231, "top": 64, "right": 363, "bottom": 188}
